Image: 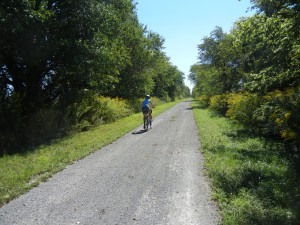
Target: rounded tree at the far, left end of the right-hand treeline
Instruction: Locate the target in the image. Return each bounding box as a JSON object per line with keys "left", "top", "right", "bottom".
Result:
{"left": 195, "top": 27, "right": 243, "bottom": 95}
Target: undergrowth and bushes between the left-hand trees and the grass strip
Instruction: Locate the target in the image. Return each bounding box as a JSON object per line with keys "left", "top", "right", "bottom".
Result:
{"left": 0, "top": 93, "right": 170, "bottom": 156}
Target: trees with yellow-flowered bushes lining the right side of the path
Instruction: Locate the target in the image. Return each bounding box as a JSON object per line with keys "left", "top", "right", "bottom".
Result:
{"left": 189, "top": 0, "right": 300, "bottom": 149}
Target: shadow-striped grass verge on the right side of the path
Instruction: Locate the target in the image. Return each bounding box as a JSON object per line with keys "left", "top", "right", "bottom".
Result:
{"left": 193, "top": 102, "right": 300, "bottom": 225}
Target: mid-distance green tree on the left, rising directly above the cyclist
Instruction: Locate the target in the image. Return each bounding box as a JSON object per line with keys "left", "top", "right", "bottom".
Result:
{"left": 110, "top": 26, "right": 163, "bottom": 99}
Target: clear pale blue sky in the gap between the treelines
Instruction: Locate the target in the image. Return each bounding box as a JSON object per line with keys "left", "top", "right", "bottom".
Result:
{"left": 136, "top": 0, "right": 254, "bottom": 87}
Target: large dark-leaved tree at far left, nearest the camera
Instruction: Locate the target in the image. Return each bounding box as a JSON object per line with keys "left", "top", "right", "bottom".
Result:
{"left": 0, "top": 0, "right": 138, "bottom": 153}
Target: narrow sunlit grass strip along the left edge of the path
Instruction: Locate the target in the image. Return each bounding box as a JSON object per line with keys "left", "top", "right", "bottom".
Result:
{"left": 0, "top": 99, "right": 178, "bottom": 206}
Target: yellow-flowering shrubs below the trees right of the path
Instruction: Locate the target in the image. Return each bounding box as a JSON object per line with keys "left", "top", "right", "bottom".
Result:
{"left": 226, "top": 87, "right": 300, "bottom": 145}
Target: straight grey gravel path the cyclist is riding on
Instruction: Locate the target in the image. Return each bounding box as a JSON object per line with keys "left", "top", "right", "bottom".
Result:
{"left": 0, "top": 101, "right": 219, "bottom": 225}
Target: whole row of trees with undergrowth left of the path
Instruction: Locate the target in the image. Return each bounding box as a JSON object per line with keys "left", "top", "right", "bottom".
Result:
{"left": 0, "top": 0, "right": 189, "bottom": 153}
